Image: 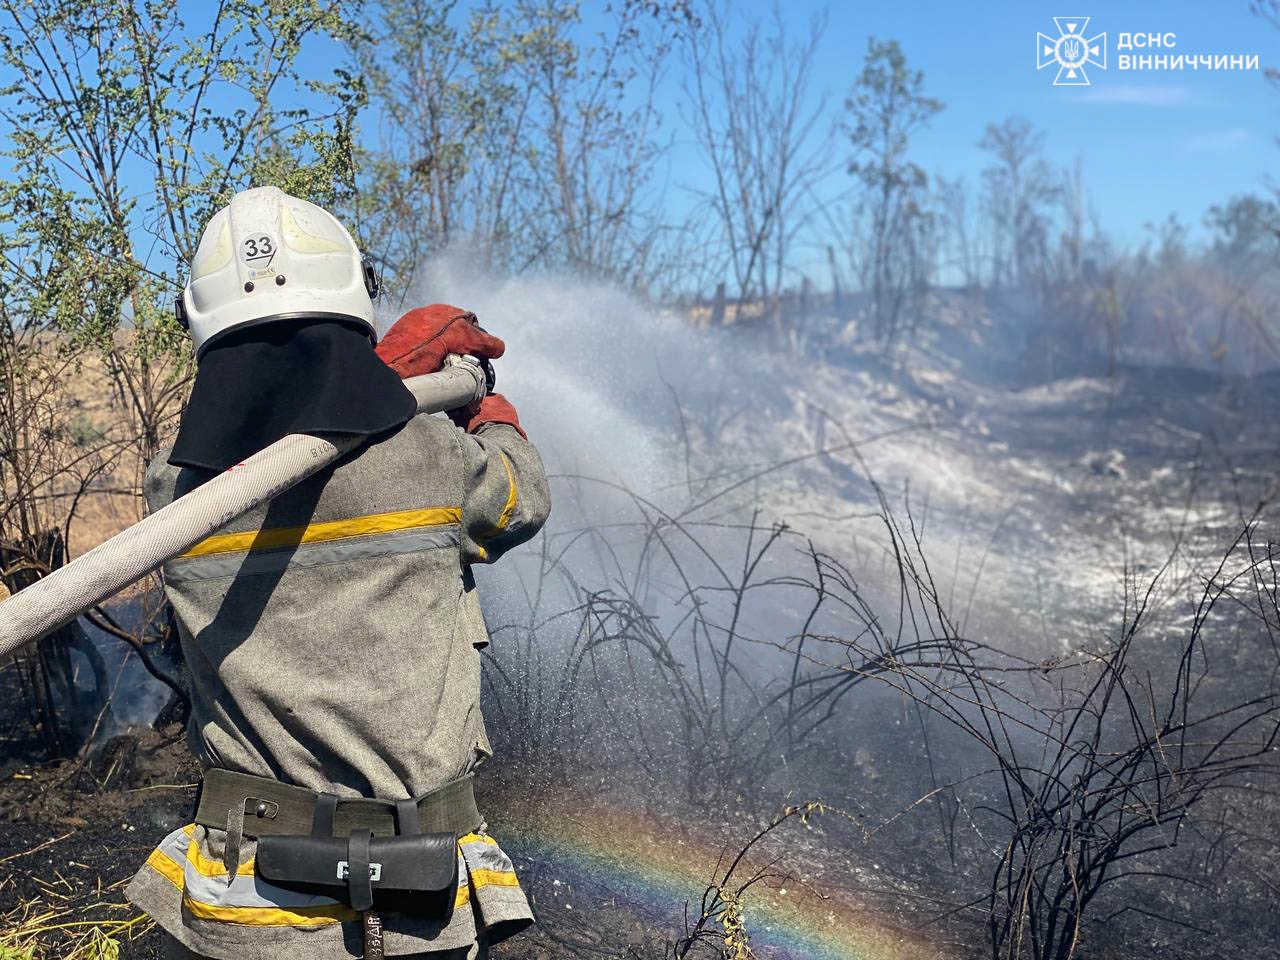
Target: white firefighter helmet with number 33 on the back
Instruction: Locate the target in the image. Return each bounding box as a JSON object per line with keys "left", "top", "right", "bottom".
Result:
{"left": 174, "top": 187, "right": 378, "bottom": 358}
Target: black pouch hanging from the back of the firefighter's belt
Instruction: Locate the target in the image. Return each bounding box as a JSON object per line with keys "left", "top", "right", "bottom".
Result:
{"left": 255, "top": 796, "right": 458, "bottom": 925}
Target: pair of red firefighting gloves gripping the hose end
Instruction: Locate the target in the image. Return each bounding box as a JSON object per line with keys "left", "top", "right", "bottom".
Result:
{"left": 376, "top": 303, "right": 529, "bottom": 440}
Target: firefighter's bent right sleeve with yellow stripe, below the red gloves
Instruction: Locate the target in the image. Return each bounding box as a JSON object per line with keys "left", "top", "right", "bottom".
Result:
{"left": 458, "top": 417, "right": 550, "bottom": 563}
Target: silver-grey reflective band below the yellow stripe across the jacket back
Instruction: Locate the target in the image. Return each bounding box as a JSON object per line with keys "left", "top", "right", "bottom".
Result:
{"left": 164, "top": 524, "right": 460, "bottom": 584}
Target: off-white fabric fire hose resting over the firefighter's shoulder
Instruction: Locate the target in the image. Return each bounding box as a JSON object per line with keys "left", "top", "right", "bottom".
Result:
{"left": 0, "top": 357, "right": 492, "bottom": 657}
